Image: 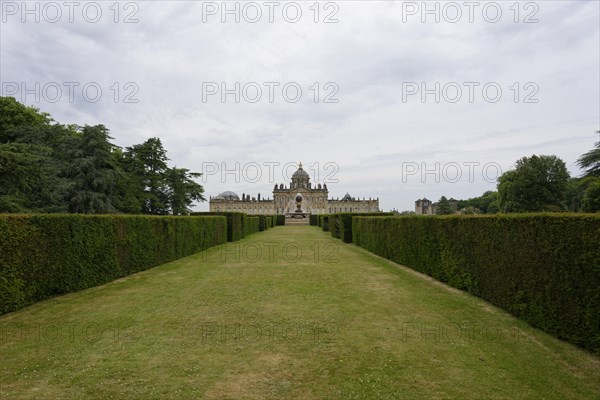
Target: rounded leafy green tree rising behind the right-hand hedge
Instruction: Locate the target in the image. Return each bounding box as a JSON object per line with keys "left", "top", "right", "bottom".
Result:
{"left": 498, "top": 155, "right": 569, "bottom": 212}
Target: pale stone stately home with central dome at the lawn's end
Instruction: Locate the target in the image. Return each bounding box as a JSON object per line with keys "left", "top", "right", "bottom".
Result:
{"left": 209, "top": 163, "right": 379, "bottom": 217}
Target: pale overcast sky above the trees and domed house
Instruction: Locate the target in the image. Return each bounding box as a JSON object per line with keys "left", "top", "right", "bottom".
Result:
{"left": 0, "top": 0, "right": 600, "bottom": 211}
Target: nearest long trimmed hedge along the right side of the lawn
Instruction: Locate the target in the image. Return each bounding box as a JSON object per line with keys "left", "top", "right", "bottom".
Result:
{"left": 352, "top": 214, "right": 600, "bottom": 353}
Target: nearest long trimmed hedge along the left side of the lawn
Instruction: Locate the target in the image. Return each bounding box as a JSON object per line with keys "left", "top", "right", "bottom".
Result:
{"left": 0, "top": 214, "right": 227, "bottom": 314}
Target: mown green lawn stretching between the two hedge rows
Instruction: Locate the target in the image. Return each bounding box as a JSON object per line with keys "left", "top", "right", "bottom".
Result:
{"left": 0, "top": 226, "right": 600, "bottom": 399}
